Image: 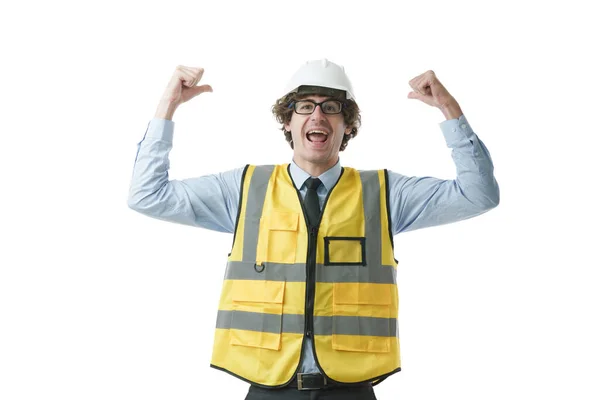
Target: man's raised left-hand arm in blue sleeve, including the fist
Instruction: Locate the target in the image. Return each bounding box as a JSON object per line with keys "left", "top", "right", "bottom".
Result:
{"left": 127, "top": 66, "right": 243, "bottom": 232}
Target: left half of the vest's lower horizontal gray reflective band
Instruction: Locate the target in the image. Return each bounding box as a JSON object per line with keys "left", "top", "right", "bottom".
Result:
{"left": 217, "top": 310, "right": 304, "bottom": 334}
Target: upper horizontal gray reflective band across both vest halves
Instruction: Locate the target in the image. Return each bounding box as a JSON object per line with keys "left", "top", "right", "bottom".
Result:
{"left": 225, "top": 261, "right": 396, "bottom": 283}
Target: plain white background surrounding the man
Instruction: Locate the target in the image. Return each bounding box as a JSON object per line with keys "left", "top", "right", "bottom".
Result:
{"left": 0, "top": 1, "right": 600, "bottom": 400}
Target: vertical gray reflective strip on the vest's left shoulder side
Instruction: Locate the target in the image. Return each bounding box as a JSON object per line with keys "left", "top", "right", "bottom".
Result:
{"left": 242, "top": 165, "right": 275, "bottom": 262}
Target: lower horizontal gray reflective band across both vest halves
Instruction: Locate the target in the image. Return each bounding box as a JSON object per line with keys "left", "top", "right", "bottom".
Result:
{"left": 217, "top": 310, "right": 397, "bottom": 337}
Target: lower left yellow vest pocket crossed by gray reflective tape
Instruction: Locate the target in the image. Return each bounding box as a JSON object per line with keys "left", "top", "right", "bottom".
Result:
{"left": 229, "top": 280, "right": 285, "bottom": 350}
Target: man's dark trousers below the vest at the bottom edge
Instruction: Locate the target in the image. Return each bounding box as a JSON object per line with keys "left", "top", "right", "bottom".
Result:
{"left": 245, "top": 385, "right": 377, "bottom": 400}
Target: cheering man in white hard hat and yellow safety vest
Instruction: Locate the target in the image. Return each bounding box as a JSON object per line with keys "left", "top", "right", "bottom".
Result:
{"left": 128, "top": 60, "right": 499, "bottom": 399}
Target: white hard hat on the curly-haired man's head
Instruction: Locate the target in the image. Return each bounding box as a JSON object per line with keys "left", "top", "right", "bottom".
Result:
{"left": 283, "top": 58, "right": 354, "bottom": 100}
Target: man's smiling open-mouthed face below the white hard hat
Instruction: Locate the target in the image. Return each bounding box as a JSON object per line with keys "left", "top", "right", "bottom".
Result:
{"left": 284, "top": 95, "right": 352, "bottom": 172}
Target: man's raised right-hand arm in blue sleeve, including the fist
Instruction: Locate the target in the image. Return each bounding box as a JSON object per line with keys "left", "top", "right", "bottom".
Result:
{"left": 388, "top": 71, "right": 500, "bottom": 234}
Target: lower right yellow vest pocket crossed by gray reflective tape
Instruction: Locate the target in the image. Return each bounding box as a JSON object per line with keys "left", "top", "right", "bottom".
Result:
{"left": 332, "top": 282, "right": 396, "bottom": 353}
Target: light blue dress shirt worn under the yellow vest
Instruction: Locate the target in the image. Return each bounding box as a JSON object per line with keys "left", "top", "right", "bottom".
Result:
{"left": 127, "top": 115, "right": 500, "bottom": 372}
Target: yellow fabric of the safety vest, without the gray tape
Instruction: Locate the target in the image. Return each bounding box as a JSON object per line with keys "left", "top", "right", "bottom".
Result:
{"left": 211, "top": 164, "right": 400, "bottom": 386}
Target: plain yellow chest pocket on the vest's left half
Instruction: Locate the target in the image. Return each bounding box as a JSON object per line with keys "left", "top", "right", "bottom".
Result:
{"left": 262, "top": 210, "right": 299, "bottom": 264}
